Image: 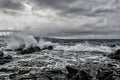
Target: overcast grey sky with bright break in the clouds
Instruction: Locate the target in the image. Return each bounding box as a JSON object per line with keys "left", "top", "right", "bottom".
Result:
{"left": 0, "top": 0, "right": 120, "bottom": 39}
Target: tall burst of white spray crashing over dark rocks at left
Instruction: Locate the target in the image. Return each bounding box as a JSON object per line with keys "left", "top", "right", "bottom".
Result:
{"left": 6, "top": 33, "right": 37, "bottom": 49}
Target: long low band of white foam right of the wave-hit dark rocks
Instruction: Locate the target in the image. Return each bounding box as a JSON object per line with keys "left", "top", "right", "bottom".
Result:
{"left": 55, "top": 43, "right": 114, "bottom": 53}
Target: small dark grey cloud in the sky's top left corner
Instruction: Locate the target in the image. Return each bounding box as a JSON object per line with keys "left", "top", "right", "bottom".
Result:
{"left": 0, "top": 0, "right": 22, "bottom": 10}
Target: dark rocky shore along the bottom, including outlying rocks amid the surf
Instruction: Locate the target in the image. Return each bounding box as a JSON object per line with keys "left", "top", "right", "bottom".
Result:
{"left": 0, "top": 46, "right": 120, "bottom": 80}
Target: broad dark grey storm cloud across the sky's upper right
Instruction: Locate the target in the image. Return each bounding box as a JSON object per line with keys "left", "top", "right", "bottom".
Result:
{"left": 35, "top": 0, "right": 117, "bottom": 17}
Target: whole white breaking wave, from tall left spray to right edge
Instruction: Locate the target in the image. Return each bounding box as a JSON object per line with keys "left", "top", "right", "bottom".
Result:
{"left": 3, "top": 33, "right": 119, "bottom": 53}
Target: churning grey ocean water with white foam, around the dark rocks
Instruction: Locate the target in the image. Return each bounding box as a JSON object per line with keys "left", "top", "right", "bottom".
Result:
{"left": 0, "top": 34, "right": 120, "bottom": 77}
